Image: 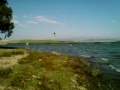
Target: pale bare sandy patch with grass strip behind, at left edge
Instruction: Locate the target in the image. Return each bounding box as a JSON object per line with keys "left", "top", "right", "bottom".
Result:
{"left": 0, "top": 49, "right": 27, "bottom": 68}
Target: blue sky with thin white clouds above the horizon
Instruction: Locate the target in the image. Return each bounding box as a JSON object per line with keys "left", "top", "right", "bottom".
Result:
{"left": 8, "top": 0, "right": 120, "bottom": 40}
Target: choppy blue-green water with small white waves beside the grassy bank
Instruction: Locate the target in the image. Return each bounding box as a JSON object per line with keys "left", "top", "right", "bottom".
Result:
{"left": 1, "top": 42, "right": 120, "bottom": 90}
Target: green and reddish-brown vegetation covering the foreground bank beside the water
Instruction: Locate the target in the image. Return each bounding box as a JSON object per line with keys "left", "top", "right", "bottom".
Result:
{"left": 0, "top": 50, "right": 115, "bottom": 90}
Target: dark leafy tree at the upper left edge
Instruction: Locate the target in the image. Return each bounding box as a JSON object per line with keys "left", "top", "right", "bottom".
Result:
{"left": 0, "top": 0, "right": 14, "bottom": 38}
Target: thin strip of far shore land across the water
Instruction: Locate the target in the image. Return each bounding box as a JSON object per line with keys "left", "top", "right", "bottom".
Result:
{"left": 0, "top": 40, "right": 120, "bottom": 45}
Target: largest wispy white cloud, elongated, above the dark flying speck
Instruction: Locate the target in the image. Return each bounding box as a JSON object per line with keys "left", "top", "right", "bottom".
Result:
{"left": 35, "top": 16, "right": 59, "bottom": 24}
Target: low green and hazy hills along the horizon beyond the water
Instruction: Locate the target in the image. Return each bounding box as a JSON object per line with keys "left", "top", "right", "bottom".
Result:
{"left": 2, "top": 39, "right": 120, "bottom": 44}
